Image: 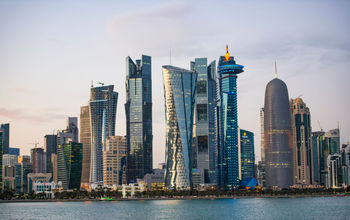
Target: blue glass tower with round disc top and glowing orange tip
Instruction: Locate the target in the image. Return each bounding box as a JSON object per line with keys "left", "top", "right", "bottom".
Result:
{"left": 216, "top": 46, "right": 243, "bottom": 189}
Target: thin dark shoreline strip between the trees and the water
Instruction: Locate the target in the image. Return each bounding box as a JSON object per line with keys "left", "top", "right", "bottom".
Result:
{"left": 0, "top": 194, "right": 349, "bottom": 203}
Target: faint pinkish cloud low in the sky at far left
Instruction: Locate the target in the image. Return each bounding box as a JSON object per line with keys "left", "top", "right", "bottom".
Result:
{"left": 0, "top": 108, "right": 67, "bottom": 123}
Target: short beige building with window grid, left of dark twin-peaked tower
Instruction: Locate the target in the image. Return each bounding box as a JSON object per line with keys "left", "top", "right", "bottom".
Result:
{"left": 103, "top": 136, "right": 127, "bottom": 186}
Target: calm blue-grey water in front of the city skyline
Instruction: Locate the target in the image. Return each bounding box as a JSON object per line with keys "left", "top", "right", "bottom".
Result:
{"left": 0, "top": 197, "right": 350, "bottom": 220}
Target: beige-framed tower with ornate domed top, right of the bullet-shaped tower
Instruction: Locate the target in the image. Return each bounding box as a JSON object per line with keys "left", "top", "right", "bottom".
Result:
{"left": 290, "top": 98, "right": 313, "bottom": 187}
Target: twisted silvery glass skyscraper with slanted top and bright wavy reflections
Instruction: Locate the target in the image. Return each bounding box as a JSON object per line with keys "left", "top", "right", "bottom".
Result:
{"left": 162, "top": 65, "right": 197, "bottom": 189}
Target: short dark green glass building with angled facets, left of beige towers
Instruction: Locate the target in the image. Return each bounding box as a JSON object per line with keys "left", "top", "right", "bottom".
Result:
{"left": 57, "top": 142, "right": 83, "bottom": 190}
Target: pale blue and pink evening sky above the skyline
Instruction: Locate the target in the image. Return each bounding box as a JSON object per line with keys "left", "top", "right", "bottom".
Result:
{"left": 0, "top": 0, "right": 350, "bottom": 166}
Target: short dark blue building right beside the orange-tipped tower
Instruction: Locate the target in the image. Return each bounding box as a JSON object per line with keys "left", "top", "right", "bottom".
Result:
{"left": 238, "top": 129, "right": 255, "bottom": 180}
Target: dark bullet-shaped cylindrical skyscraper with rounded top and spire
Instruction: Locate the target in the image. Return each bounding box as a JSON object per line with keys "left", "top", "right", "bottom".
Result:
{"left": 264, "top": 74, "right": 293, "bottom": 189}
